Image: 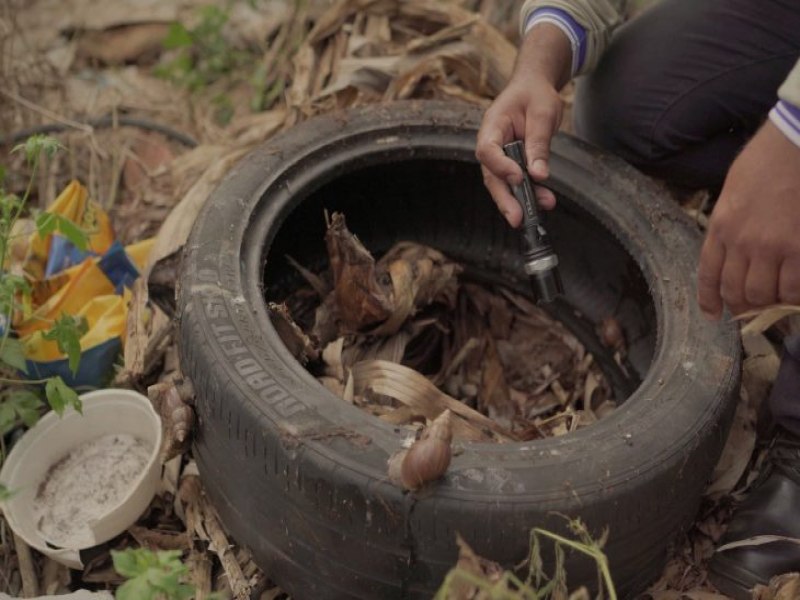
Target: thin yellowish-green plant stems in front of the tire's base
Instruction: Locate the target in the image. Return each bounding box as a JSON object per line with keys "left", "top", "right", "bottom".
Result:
{"left": 435, "top": 519, "right": 617, "bottom": 600}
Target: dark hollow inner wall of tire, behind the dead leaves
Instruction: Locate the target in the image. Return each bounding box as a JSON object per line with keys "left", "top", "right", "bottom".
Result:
{"left": 263, "top": 156, "right": 658, "bottom": 412}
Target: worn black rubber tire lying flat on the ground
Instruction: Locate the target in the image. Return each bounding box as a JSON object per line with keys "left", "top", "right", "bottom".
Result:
{"left": 178, "top": 102, "right": 741, "bottom": 599}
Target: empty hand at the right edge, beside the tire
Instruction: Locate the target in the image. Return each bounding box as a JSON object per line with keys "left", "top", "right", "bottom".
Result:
{"left": 697, "top": 121, "right": 800, "bottom": 319}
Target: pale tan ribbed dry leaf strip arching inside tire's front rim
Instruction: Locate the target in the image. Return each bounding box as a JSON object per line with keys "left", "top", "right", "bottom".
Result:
{"left": 352, "top": 360, "right": 516, "bottom": 442}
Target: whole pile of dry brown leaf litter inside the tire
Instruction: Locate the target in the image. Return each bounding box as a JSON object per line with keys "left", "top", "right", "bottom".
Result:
{"left": 273, "top": 213, "right": 623, "bottom": 454}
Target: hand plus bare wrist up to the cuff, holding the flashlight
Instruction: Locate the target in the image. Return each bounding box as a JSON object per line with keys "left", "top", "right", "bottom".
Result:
{"left": 475, "top": 23, "right": 572, "bottom": 227}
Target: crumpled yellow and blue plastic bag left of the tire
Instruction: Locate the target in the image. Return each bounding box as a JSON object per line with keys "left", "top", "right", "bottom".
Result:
{"left": 14, "top": 181, "right": 154, "bottom": 387}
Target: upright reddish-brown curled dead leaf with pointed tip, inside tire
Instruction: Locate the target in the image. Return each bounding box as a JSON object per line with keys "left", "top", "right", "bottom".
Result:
{"left": 325, "top": 213, "right": 392, "bottom": 332}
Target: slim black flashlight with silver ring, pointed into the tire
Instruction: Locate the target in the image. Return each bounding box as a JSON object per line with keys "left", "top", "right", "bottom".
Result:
{"left": 503, "top": 140, "right": 564, "bottom": 302}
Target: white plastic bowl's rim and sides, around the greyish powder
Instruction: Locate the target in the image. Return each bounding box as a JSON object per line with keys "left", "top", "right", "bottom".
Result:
{"left": 0, "top": 389, "right": 161, "bottom": 569}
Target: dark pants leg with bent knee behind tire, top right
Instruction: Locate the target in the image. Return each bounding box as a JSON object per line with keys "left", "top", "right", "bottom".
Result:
{"left": 574, "top": 0, "right": 800, "bottom": 189}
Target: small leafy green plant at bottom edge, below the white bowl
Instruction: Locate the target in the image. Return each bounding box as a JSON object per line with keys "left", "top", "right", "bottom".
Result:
{"left": 111, "top": 548, "right": 219, "bottom": 600}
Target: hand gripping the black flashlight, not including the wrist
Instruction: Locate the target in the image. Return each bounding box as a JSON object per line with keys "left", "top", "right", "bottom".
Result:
{"left": 475, "top": 74, "right": 562, "bottom": 227}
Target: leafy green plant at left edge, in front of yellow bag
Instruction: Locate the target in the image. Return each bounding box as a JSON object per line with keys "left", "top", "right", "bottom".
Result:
{"left": 0, "top": 135, "right": 88, "bottom": 498}
